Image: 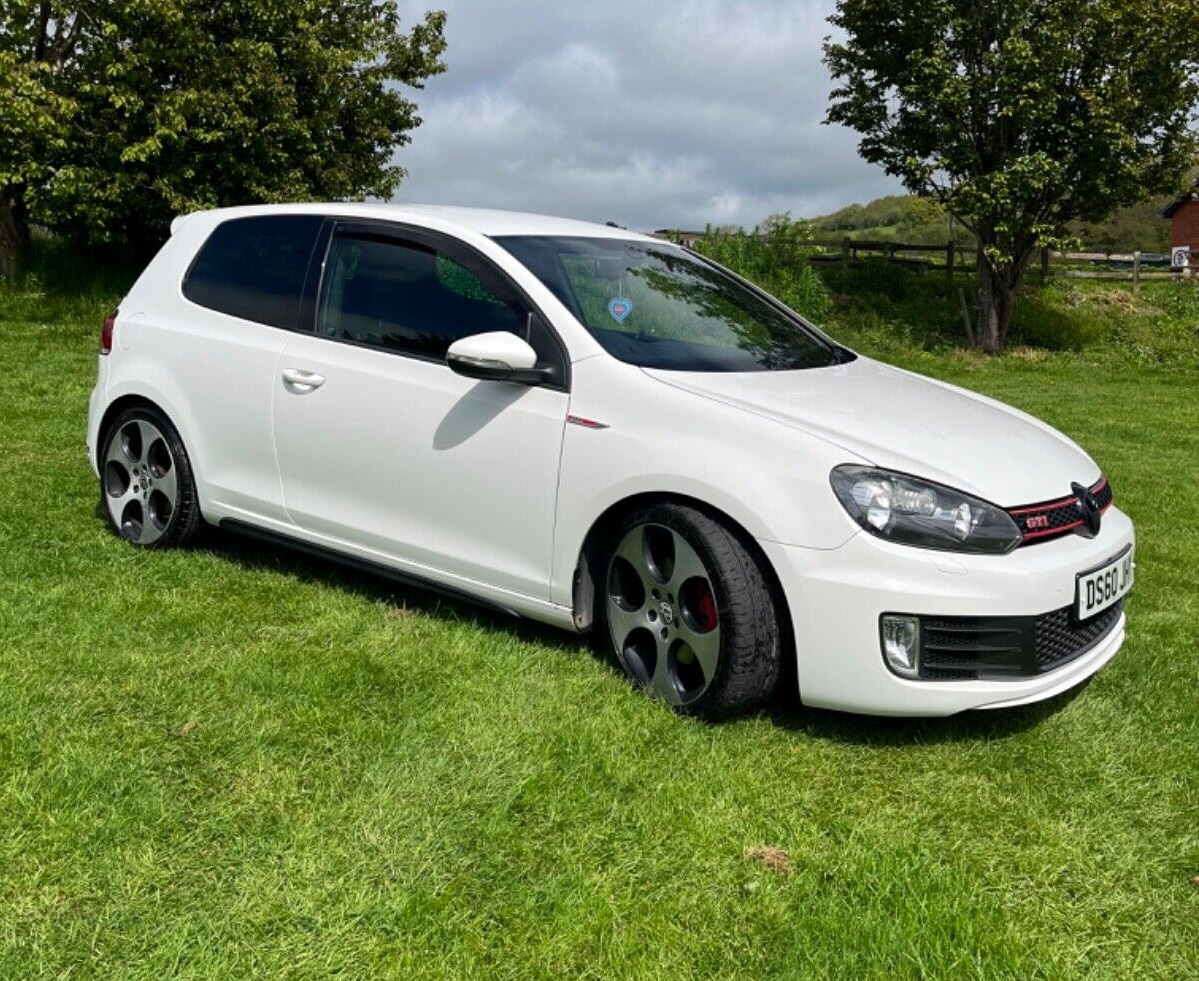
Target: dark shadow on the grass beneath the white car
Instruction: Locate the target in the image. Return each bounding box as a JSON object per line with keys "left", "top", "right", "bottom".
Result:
{"left": 194, "top": 527, "right": 1089, "bottom": 747}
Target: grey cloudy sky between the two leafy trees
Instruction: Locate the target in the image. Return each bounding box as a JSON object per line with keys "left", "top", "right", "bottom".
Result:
{"left": 388, "top": 0, "right": 897, "bottom": 229}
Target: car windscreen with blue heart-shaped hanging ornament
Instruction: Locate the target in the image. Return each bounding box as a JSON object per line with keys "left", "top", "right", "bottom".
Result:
{"left": 496, "top": 236, "right": 845, "bottom": 372}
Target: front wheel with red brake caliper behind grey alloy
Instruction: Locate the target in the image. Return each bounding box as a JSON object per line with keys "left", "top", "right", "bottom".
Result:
{"left": 600, "top": 504, "right": 782, "bottom": 720}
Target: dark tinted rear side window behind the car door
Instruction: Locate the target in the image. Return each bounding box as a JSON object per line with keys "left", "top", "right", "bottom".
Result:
{"left": 183, "top": 215, "right": 323, "bottom": 330}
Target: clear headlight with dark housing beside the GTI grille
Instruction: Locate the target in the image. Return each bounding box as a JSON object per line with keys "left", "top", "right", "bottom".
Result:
{"left": 830, "top": 464, "right": 1020, "bottom": 554}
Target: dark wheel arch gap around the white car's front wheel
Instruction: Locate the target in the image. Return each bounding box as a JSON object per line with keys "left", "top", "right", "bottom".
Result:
{"left": 571, "top": 492, "right": 795, "bottom": 670}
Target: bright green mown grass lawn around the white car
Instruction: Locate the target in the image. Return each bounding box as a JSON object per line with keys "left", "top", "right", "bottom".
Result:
{"left": 0, "top": 261, "right": 1199, "bottom": 981}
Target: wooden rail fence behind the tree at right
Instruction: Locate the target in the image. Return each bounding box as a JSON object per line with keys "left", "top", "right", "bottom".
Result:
{"left": 807, "top": 239, "right": 1199, "bottom": 289}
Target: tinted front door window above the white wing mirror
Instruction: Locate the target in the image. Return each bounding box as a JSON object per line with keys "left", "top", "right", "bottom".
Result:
{"left": 317, "top": 235, "right": 525, "bottom": 357}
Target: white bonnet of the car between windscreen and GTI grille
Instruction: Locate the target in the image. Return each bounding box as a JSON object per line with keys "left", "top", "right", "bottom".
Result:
{"left": 644, "top": 357, "right": 1099, "bottom": 507}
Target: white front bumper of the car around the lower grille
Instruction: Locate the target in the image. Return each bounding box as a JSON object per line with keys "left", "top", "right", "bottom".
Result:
{"left": 760, "top": 507, "right": 1134, "bottom": 716}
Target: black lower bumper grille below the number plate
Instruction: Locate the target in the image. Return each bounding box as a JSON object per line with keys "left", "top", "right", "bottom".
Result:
{"left": 920, "top": 600, "right": 1123, "bottom": 681}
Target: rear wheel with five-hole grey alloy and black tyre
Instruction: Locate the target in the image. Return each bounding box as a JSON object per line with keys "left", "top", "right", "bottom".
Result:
{"left": 100, "top": 405, "right": 200, "bottom": 548}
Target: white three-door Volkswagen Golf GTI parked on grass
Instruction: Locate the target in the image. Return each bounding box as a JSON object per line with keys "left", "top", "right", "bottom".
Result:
{"left": 88, "top": 204, "right": 1133, "bottom": 718}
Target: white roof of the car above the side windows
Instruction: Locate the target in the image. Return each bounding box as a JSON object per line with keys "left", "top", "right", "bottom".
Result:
{"left": 171, "top": 201, "right": 655, "bottom": 241}
